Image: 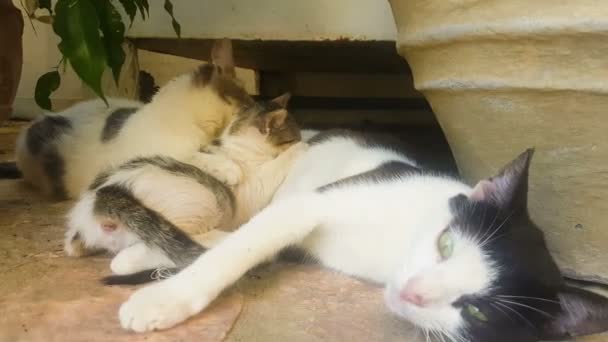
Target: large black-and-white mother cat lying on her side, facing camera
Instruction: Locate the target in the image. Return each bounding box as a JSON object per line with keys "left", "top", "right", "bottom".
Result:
{"left": 114, "top": 132, "right": 608, "bottom": 342}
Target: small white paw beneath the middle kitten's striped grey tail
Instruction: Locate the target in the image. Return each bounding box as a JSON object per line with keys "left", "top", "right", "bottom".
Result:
{"left": 110, "top": 242, "right": 175, "bottom": 275}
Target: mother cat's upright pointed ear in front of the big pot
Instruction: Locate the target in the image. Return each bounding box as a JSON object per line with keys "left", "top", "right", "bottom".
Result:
{"left": 469, "top": 149, "right": 534, "bottom": 209}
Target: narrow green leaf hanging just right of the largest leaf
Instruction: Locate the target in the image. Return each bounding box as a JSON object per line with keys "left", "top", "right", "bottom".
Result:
{"left": 93, "top": 0, "right": 125, "bottom": 85}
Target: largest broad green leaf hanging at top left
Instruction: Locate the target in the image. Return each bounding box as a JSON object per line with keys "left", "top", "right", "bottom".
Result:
{"left": 53, "top": 0, "right": 107, "bottom": 104}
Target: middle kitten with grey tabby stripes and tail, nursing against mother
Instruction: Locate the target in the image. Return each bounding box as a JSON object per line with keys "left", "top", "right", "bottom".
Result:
{"left": 65, "top": 94, "right": 305, "bottom": 274}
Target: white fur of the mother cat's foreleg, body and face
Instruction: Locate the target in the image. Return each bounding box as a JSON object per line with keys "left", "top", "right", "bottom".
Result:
{"left": 119, "top": 133, "right": 494, "bottom": 332}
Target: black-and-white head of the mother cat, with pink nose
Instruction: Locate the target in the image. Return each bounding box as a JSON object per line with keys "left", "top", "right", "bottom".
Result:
{"left": 385, "top": 150, "right": 608, "bottom": 342}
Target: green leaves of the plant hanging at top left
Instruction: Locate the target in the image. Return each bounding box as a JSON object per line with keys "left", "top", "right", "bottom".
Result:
{"left": 24, "top": 0, "right": 181, "bottom": 110}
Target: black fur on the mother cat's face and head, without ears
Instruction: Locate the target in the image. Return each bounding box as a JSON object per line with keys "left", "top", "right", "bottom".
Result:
{"left": 442, "top": 195, "right": 563, "bottom": 342}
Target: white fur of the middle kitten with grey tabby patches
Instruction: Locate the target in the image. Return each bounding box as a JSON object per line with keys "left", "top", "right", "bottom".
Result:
{"left": 65, "top": 113, "right": 306, "bottom": 264}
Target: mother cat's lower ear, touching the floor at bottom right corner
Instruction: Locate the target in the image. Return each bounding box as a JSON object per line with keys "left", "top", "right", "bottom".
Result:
{"left": 539, "top": 286, "right": 608, "bottom": 340}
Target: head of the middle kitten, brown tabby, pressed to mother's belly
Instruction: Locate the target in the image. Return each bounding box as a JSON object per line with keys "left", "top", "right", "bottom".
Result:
{"left": 215, "top": 93, "right": 301, "bottom": 158}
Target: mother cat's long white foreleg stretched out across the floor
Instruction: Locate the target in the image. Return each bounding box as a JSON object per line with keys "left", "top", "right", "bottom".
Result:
{"left": 119, "top": 193, "right": 328, "bottom": 332}
